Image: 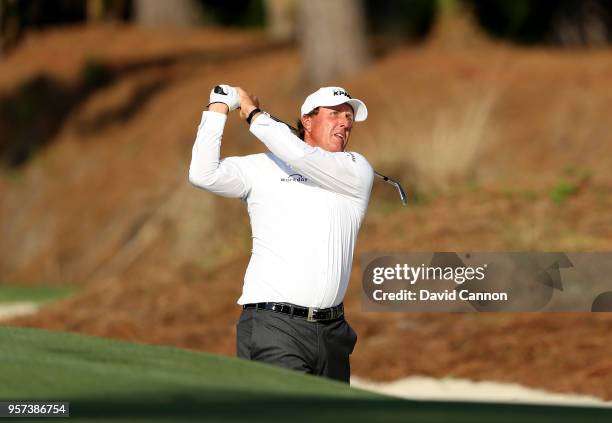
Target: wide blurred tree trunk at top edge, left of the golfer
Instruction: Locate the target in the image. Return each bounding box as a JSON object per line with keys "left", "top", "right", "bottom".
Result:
{"left": 134, "top": 0, "right": 203, "bottom": 27}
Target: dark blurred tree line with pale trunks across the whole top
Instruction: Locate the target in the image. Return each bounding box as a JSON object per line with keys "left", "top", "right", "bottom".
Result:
{"left": 0, "top": 0, "right": 612, "bottom": 83}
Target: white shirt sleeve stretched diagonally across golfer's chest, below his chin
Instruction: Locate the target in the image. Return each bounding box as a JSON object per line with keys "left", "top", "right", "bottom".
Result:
{"left": 250, "top": 113, "right": 374, "bottom": 202}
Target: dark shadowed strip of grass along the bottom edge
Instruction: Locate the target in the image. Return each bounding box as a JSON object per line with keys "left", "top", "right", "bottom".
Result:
{"left": 70, "top": 390, "right": 612, "bottom": 423}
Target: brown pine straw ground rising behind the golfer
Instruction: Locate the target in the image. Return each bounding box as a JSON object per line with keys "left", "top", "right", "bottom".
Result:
{"left": 0, "top": 26, "right": 612, "bottom": 400}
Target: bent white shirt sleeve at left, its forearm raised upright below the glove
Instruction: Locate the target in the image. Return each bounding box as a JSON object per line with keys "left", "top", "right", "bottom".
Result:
{"left": 189, "top": 111, "right": 250, "bottom": 199}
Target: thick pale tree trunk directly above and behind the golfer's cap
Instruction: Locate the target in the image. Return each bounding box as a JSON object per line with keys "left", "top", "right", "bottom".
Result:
{"left": 299, "top": 0, "right": 369, "bottom": 84}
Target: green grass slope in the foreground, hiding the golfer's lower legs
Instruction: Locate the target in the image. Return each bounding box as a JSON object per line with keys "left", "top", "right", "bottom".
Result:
{"left": 0, "top": 327, "right": 612, "bottom": 423}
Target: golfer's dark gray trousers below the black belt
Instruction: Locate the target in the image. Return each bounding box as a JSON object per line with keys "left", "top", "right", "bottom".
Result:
{"left": 236, "top": 309, "right": 357, "bottom": 383}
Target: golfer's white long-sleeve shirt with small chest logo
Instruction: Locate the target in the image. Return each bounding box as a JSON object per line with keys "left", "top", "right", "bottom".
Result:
{"left": 189, "top": 112, "right": 374, "bottom": 308}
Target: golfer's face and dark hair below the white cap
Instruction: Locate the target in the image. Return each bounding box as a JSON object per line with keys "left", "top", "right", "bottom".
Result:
{"left": 302, "top": 103, "right": 354, "bottom": 152}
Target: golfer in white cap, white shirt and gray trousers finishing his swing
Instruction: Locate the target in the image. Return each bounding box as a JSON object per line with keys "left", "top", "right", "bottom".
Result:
{"left": 189, "top": 85, "right": 374, "bottom": 382}
